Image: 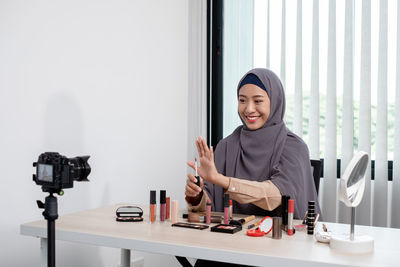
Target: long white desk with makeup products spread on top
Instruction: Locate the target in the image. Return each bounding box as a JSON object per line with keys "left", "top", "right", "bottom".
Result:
{"left": 21, "top": 205, "right": 400, "bottom": 266}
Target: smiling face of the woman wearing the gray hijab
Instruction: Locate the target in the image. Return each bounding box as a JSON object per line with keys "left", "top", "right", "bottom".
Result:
{"left": 238, "top": 84, "right": 271, "bottom": 130}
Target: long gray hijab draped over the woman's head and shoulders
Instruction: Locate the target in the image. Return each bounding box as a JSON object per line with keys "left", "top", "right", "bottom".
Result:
{"left": 205, "top": 68, "right": 320, "bottom": 218}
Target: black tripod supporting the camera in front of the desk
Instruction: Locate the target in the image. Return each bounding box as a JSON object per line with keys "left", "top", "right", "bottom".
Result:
{"left": 36, "top": 192, "right": 58, "bottom": 267}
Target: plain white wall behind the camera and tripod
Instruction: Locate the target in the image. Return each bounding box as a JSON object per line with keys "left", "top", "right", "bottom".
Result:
{"left": 0, "top": 0, "right": 188, "bottom": 266}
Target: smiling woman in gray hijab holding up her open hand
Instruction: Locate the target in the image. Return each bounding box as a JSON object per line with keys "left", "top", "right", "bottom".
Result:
{"left": 185, "top": 69, "right": 320, "bottom": 221}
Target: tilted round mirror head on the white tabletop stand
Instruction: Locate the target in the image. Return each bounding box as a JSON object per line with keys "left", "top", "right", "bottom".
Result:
{"left": 339, "top": 151, "right": 369, "bottom": 207}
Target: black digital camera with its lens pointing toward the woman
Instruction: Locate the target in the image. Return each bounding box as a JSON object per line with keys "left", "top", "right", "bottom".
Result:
{"left": 33, "top": 152, "right": 91, "bottom": 193}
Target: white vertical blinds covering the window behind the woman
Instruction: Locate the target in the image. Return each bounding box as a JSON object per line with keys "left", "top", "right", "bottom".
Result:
{"left": 223, "top": 0, "right": 400, "bottom": 227}
